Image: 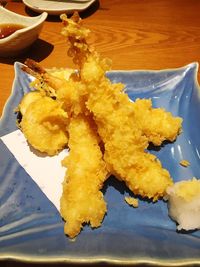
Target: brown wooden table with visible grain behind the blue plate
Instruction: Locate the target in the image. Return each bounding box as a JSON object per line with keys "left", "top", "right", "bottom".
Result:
{"left": 0, "top": 0, "right": 200, "bottom": 267}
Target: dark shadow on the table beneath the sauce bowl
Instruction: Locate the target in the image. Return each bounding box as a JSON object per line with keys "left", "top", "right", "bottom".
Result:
{"left": 0, "top": 39, "right": 53, "bottom": 65}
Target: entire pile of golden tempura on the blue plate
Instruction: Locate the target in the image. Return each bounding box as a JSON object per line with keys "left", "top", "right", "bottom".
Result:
{"left": 16, "top": 13, "right": 182, "bottom": 238}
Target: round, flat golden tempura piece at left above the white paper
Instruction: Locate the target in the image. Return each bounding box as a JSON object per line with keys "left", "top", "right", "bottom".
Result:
{"left": 20, "top": 96, "right": 68, "bottom": 156}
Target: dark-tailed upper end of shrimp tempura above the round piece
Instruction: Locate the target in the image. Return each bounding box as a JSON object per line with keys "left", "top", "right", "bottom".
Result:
{"left": 22, "top": 59, "right": 88, "bottom": 117}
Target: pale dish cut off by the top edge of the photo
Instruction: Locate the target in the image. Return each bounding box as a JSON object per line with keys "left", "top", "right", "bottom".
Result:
{"left": 22, "top": 0, "right": 95, "bottom": 15}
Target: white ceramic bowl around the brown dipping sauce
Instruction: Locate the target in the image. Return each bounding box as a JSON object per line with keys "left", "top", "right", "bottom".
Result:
{"left": 0, "top": 6, "right": 48, "bottom": 57}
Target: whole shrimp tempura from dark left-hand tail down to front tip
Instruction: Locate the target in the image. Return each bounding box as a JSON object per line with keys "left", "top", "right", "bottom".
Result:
{"left": 21, "top": 60, "right": 108, "bottom": 238}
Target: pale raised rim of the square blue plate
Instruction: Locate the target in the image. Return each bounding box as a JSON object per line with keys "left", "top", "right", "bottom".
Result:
{"left": 0, "top": 63, "right": 200, "bottom": 266}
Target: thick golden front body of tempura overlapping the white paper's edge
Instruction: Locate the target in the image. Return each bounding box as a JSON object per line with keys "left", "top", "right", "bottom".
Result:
{"left": 60, "top": 115, "right": 107, "bottom": 238}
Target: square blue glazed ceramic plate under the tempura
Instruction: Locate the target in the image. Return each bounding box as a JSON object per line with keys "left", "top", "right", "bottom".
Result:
{"left": 0, "top": 63, "right": 200, "bottom": 266}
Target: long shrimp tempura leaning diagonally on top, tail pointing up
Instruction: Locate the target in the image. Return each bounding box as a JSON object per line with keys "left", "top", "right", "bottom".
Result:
{"left": 61, "top": 12, "right": 175, "bottom": 200}
